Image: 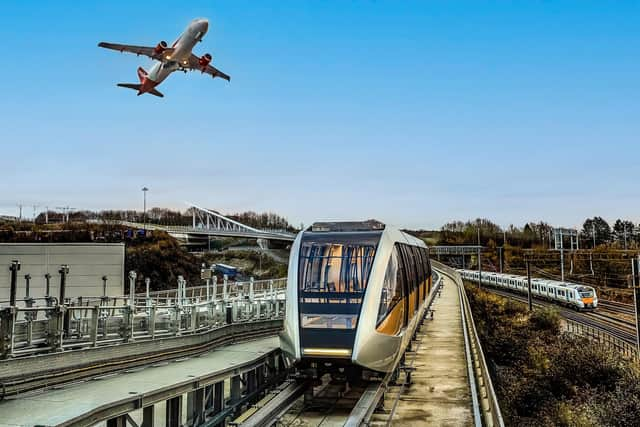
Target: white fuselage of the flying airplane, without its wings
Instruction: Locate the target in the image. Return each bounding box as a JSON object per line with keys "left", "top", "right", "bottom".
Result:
{"left": 140, "top": 18, "right": 209, "bottom": 93}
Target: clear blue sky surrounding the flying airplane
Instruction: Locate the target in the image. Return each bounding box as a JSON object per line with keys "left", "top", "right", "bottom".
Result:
{"left": 0, "top": 0, "right": 640, "bottom": 228}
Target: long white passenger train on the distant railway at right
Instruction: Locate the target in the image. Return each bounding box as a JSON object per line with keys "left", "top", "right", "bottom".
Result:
{"left": 458, "top": 270, "right": 598, "bottom": 310}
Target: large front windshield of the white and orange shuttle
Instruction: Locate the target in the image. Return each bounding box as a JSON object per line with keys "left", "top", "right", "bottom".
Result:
{"left": 298, "top": 232, "right": 381, "bottom": 329}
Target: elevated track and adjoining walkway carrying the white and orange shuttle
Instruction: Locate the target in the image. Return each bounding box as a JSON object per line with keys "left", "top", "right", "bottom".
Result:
{"left": 232, "top": 262, "right": 504, "bottom": 427}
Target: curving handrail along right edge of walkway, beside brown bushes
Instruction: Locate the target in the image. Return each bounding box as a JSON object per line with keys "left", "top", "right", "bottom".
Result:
{"left": 431, "top": 260, "right": 504, "bottom": 427}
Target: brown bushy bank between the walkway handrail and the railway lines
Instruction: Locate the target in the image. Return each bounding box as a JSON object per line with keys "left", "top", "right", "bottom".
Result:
{"left": 467, "top": 286, "right": 640, "bottom": 426}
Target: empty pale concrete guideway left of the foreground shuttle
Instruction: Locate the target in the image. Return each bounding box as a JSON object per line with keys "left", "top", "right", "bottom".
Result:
{"left": 0, "top": 336, "right": 283, "bottom": 426}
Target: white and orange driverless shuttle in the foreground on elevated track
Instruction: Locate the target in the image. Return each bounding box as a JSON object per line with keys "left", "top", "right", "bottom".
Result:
{"left": 280, "top": 220, "right": 432, "bottom": 373}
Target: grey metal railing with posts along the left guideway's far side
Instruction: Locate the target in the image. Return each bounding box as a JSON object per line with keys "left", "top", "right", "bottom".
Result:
{"left": 0, "top": 279, "right": 286, "bottom": 358}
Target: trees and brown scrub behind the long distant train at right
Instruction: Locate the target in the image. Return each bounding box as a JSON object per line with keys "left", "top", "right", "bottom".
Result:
{"left": 411, "top": 217, "right": 640, "bottom": 303}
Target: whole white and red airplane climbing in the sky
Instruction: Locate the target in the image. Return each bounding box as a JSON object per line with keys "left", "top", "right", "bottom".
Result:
{"left": 98, "top": 18, "right": 231, "bottom": 98}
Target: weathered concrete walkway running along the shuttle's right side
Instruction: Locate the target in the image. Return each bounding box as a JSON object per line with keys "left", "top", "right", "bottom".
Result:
{"left": 393, "top": 276, "right": 473, "bottom": 426}
